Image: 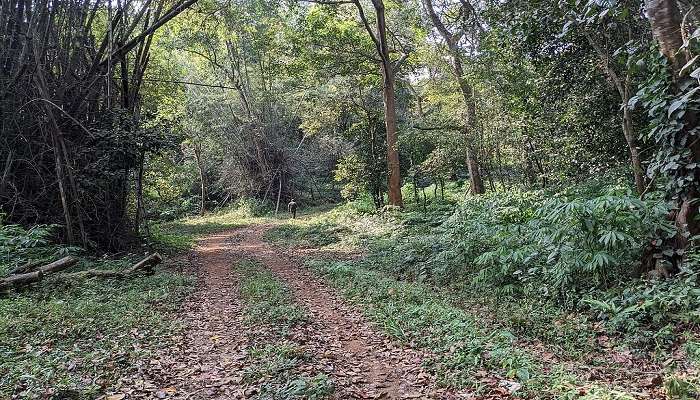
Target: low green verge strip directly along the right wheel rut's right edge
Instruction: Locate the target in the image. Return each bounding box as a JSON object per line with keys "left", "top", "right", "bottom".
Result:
{"left": 307, "top": 260, "right": 668, "bottom": 400}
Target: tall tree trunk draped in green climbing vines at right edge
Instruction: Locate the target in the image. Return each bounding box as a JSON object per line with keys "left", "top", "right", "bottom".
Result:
{"left": 646, "top": 0, "right": 700, "bottom": 268}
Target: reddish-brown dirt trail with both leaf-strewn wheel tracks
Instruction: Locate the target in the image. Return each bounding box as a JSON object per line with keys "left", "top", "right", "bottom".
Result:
{"left": 123, "top": 225, "right": 464, "bottom": 399}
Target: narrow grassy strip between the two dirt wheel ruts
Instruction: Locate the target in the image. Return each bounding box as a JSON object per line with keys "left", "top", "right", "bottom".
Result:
{"left": 235, "top": 259, "right": 333, "bottom": 400}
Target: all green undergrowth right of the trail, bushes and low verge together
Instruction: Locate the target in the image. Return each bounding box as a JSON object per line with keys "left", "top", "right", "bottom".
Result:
{"left": 267, "top": 185, "right": 700, "bottom": 399}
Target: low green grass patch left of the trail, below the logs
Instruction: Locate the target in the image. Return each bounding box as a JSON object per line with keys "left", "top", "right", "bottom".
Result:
{"left": 0, "top": 262, "right": 193, "bottom": 399}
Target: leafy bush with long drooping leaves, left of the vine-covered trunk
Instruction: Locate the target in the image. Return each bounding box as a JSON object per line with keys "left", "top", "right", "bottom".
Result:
{"left": 474, "top": 193, "right": 675, "bottom": 296}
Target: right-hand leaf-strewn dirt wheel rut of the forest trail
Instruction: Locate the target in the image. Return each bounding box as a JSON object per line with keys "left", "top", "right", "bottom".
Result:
{"left": 237, "top": 225, "right": 450, "bottom": 399}
